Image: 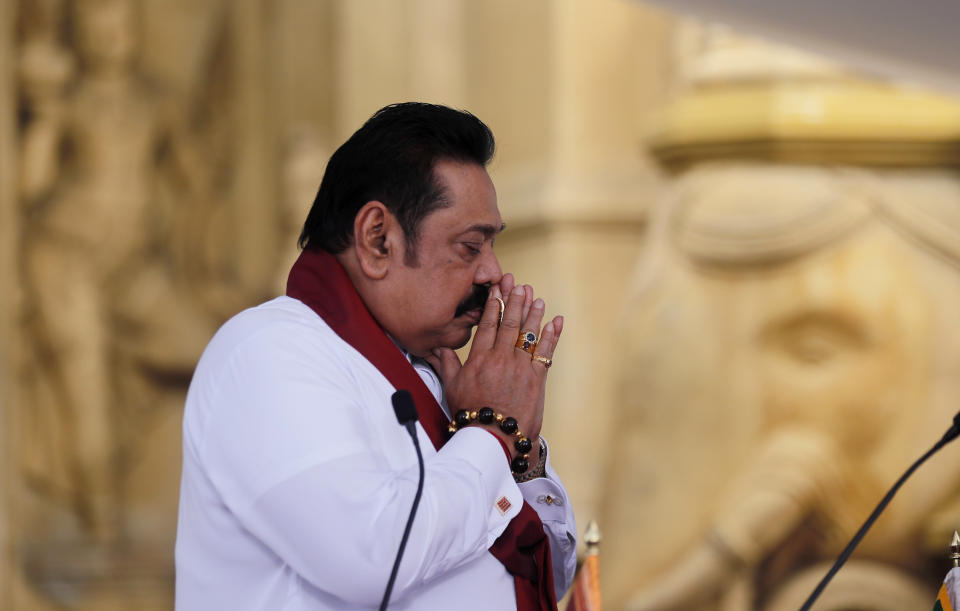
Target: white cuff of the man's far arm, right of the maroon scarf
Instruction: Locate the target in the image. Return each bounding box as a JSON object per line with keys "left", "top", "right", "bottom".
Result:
{"left": 516, "top": 433, "right": 577, "bottom": 600}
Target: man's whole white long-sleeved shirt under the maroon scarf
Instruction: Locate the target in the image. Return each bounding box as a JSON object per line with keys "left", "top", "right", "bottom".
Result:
{"left": 176, "top": 297, "right": 576, "bottom": 611}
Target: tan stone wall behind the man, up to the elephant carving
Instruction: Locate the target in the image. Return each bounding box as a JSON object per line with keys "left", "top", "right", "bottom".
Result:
{"left": 0, "top": 0, "right": 670, "bottom": 611}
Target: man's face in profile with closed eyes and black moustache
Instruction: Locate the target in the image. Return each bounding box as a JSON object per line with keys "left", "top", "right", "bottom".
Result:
{"left": 380, "top": 161, "right": 503, "bottom": 356}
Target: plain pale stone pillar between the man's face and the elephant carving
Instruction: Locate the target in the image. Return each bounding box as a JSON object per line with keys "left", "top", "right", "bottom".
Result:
{"left": 470, "top": 0, "right": 670, "bottom": 530}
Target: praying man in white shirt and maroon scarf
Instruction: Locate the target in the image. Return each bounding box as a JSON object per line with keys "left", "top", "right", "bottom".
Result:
{"left": 176, "top": 103, "right": 576, "bottom": 611}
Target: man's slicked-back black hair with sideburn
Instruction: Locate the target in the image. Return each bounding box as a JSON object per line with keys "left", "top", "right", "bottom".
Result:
{"left": 299, "top": 102, "right": 494, "bottom": 261}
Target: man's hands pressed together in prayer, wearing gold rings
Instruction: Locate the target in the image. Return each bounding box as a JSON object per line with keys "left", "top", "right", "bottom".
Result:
{"left": 427, "top": 274, "right": 563, "bottom": 457}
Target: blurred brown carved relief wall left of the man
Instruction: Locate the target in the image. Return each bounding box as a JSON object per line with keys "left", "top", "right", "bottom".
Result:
{"left": 15, "top": 0, "right": 258, "bottom": 609}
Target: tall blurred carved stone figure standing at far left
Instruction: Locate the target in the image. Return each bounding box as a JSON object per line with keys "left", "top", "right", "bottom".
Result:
{"left": 21, "top": 0, "right": 209, "bottom": 541}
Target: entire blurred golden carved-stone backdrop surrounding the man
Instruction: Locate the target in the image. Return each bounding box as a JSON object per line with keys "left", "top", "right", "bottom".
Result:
{"left": 0, "top": 0, "right": 960, "bottom": 611}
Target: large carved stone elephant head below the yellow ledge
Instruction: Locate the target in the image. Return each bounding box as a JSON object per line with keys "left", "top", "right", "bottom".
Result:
{"left": 604, "top": 162, "right": 960, "bottom": 610}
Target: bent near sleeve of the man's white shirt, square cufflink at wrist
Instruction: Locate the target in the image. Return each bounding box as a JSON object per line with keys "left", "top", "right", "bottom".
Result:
{"left": 200, "top": 328, "right": 522, "bottom": 606}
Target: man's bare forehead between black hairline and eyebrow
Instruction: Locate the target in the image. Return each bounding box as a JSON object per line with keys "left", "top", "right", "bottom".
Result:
{"left": 428, "top": 161, "right": 503, "bottom": 236}
